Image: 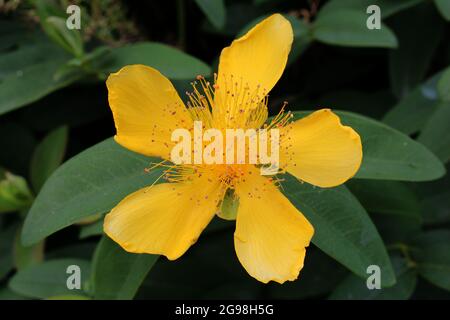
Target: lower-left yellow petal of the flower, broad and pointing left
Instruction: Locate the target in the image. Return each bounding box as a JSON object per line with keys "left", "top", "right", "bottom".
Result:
{"left": 104, "top": 175, "right": 224, "bottom": 260}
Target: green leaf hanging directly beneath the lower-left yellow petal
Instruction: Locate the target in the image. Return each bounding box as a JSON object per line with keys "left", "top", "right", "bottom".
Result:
{"left": 92, "top": 236, "right": 159, "bottom": 300}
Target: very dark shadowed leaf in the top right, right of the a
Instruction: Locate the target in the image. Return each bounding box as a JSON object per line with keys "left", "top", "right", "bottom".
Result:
{"left": 389, "top": 3, "right": 445, "bottom": 97}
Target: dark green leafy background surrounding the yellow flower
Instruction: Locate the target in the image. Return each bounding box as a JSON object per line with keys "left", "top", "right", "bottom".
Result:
{"left": 0, "top": 0, "right": 450, "bottom": 300}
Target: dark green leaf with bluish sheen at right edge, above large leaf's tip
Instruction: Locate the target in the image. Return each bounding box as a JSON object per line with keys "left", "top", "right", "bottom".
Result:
{"left": 383, "top": 68, "right": 450, "bottom": 135}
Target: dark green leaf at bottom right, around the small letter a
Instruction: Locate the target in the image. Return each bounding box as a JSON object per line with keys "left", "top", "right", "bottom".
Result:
{"left": 329, "top": 257, "right": 417, "bottom": 300}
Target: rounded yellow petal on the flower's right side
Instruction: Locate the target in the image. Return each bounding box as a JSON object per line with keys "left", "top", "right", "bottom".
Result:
{"left": 280, "top": 109, "right": 362, "bottom": 188}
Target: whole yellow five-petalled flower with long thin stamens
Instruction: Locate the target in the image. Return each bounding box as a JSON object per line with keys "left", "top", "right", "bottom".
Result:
{"left": 104, "top": 14, "right": 362, "bottom": 283}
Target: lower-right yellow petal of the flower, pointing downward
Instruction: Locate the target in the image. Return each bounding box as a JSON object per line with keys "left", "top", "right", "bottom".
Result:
{"left": 234, "top": 170, "right": 314, "bottom": 283}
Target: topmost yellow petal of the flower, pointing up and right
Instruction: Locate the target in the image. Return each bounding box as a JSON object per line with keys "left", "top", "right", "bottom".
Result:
{"left": 215, "top": 14, "right": 293, "bottom": 125}
